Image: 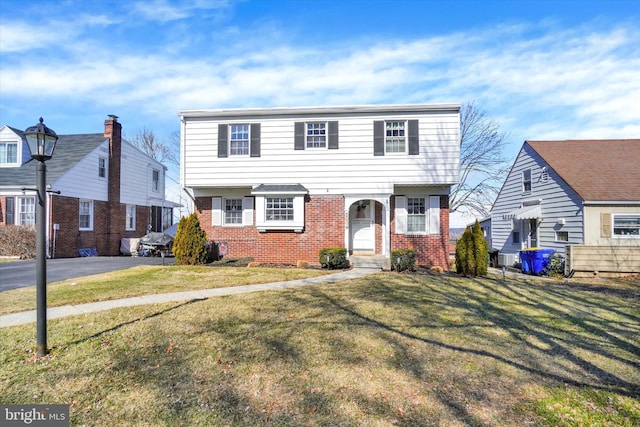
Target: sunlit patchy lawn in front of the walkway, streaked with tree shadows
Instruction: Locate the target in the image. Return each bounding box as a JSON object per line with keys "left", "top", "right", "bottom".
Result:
{"left": 0, "top": 269, "right": 640, "bottom": 426}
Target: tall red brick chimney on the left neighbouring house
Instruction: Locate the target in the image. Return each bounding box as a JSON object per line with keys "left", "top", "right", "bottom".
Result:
{"left": 104, "top": 114, "right": 125, "bottom": 256}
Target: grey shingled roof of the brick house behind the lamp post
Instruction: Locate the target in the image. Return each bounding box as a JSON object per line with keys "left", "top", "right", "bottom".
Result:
{"left": 0, "top": 133, "right": 108, "bottom": 187}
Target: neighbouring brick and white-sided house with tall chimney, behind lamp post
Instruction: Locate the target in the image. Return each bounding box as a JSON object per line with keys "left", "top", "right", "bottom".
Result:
{"left": 0, "top": 116, "right": 175, "bottom": 258}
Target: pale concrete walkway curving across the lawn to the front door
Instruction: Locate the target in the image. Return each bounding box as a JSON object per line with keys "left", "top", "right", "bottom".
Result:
{"left": 0, "top": 268, "right": 380, "bottom": 328}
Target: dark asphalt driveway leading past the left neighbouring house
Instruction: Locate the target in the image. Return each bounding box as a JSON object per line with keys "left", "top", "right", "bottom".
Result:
{"left": 0, "top": 256, "right": 175, "bottom": 292}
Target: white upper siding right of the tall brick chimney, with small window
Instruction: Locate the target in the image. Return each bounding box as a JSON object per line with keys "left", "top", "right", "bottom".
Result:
{"left": 120, "top": 141, "right": 165, "bottom": 206}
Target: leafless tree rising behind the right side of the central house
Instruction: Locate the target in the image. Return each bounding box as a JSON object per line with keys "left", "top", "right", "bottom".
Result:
{"left": 449, "top": 102, "right": 509, "bottom": 217}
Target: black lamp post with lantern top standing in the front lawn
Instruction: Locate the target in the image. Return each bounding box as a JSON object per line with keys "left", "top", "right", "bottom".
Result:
{"left": 24, "top": 117, "right": 58, "bottom": 357}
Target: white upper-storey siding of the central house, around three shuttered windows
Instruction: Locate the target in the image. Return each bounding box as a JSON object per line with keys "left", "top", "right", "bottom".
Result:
{"left": 182, "top": 111, "right": 460, "bottom": 198}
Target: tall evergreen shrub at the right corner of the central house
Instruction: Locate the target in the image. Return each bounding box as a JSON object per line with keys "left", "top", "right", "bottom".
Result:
{"left": 456, "top": 221, "right": 489, "bottom": 276}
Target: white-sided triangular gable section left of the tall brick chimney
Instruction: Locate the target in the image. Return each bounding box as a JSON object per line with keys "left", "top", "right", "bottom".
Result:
{"left": 52, "top": 140, "right": 109, "bottom": 201}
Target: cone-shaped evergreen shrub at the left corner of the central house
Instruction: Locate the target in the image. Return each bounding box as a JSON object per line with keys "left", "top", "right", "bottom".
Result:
{"left": 173, "top": 213, "right": 209, "bottom": 265}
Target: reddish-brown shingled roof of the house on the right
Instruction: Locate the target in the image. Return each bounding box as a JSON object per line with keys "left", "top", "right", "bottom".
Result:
{"left": 525, "top": 139, "right": 640, "bottom": 202}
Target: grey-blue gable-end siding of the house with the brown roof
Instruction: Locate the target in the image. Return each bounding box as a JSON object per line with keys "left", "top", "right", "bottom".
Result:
{"left": 491, "top": 144, "right": 584, "bottom": 254}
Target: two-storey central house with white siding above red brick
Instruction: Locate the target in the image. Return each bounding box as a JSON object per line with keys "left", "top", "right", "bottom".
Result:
{"left": 180, "top": 104, "right": 460, "bottom": 268}
